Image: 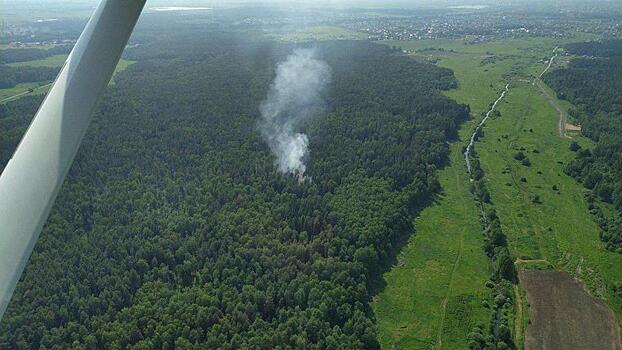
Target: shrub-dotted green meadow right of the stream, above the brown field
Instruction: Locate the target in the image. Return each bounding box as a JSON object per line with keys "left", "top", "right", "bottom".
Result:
{"left": 476, "top": 82, "right": 622, "bottom": 320}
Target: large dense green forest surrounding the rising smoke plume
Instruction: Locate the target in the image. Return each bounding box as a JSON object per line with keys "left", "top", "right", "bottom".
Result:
{"left": 0, "top": 32, "right": 469, "bottom": 349}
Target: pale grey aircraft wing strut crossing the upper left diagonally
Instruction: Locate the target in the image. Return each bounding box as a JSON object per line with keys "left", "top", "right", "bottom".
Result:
{"left": 0, "top": 0, "right": 145, "bottom": 319}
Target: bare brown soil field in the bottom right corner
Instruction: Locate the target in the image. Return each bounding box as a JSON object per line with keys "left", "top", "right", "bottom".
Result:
{"left": 519, "top": 270, "right": 622, "bottom": 350}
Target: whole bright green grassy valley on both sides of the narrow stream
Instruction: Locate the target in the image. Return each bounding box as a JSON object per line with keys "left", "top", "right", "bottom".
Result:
{"left": 373, "top": 35, "right": 622, "bottom": 349}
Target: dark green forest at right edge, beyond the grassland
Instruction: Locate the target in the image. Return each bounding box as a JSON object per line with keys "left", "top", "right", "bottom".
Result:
{"left": 545, "top": 40, "right": 622, "bottom": 253}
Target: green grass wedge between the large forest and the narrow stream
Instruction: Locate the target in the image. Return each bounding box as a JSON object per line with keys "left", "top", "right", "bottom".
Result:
{"left": 373, "top": 143, "right": 489, "bottom": 349}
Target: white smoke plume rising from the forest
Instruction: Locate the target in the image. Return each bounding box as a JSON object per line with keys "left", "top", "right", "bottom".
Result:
{"left": 260, "top": 49, "right": 330, "bottom": 179}
